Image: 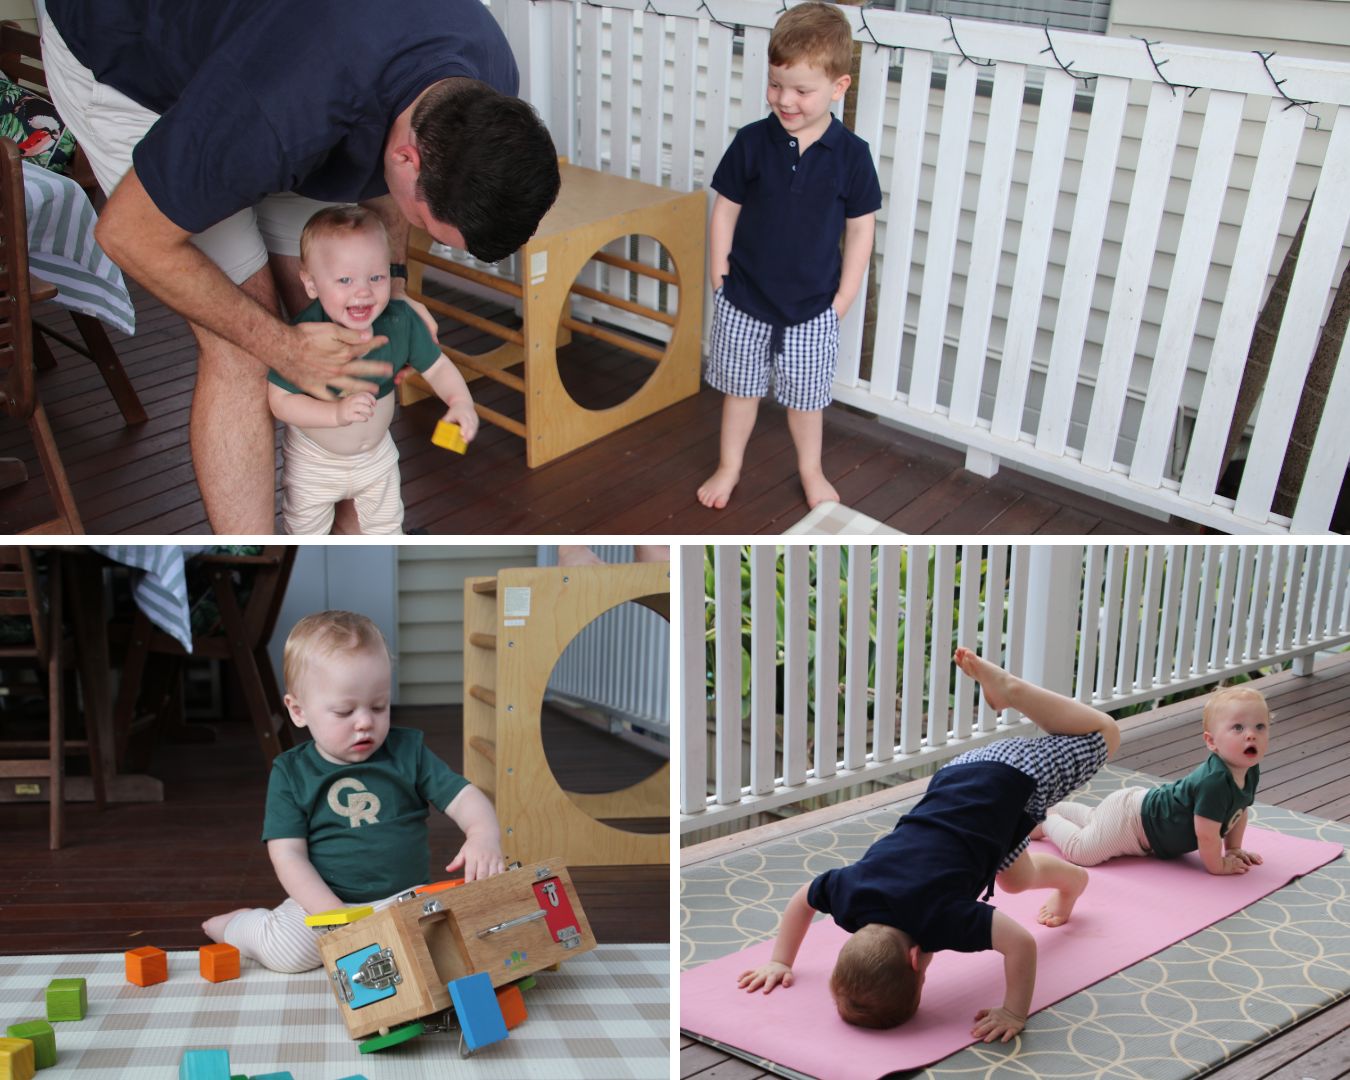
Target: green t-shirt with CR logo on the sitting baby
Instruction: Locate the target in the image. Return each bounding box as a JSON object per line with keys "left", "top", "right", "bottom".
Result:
{"left": 262, "top": 728, "right": 468, "bottom": 903}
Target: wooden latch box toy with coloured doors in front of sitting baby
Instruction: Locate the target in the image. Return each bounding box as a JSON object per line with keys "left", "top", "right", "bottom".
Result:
{"left": 319, "top": 859, "right": 595, "bottom": 1038}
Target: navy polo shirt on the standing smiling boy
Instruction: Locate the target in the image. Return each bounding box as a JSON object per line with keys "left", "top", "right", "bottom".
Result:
{"left": 711, "top": 113, "right": 882, "bottom": 327}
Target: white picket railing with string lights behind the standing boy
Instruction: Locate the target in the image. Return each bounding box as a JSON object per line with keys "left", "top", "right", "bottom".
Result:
{"left": 489, "top": 0, "right": 1350, "bottom": 533}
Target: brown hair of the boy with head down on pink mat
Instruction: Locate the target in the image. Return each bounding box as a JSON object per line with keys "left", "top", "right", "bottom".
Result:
{"left": 830, "top": 922, "right": 922, "bottom": 1029}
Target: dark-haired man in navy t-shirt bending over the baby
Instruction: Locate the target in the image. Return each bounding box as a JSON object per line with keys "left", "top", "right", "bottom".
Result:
{"left": 42, "top": 0, "right": 559, "bottom": 533}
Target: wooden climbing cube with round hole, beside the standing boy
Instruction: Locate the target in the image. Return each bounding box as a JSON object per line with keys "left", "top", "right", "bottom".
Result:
{"left": 400, "top": 163, "right": 707, "bottom": 468}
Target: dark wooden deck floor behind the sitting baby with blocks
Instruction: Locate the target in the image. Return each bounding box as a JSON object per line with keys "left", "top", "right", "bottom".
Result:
{"left": 0, "top": 706, "right": 670, "bottom": 954}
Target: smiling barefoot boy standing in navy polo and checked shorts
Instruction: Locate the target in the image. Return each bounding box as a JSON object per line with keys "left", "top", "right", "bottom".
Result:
{"left": 698, "top": 3, "right": 882, "bottom": 509}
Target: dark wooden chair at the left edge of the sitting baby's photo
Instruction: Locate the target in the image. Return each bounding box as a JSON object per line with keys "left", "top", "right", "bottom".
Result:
{"left": 0, "top": 547, "right": 105, "bottom": 851}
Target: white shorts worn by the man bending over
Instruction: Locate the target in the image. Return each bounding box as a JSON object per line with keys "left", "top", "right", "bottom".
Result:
{"left": 42, "top": 19, "right": 328, "bottom": 285}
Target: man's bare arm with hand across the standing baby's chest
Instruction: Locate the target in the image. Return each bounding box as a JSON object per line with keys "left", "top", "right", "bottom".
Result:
{"left": 95, "top": 162, "right": 389, "bottom": 398}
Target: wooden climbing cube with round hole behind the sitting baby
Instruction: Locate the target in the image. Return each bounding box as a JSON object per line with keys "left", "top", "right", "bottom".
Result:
{"left": 464, "top": 563, "right": 670, "bottom": 865}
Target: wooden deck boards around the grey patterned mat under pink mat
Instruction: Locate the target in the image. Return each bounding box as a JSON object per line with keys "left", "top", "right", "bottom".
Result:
{"left": 679, "top": 653, "right": 1350, "bottom": 1080}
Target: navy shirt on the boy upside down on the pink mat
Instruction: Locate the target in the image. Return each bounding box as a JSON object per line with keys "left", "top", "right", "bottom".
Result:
{"left": 806, "top": 761, "right": 1035, "bottom": 953}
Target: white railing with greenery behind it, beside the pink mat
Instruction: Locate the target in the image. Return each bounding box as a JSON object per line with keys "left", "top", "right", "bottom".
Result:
{"left": 679, "top": 544, "right": 1350, "bottom": 832}
